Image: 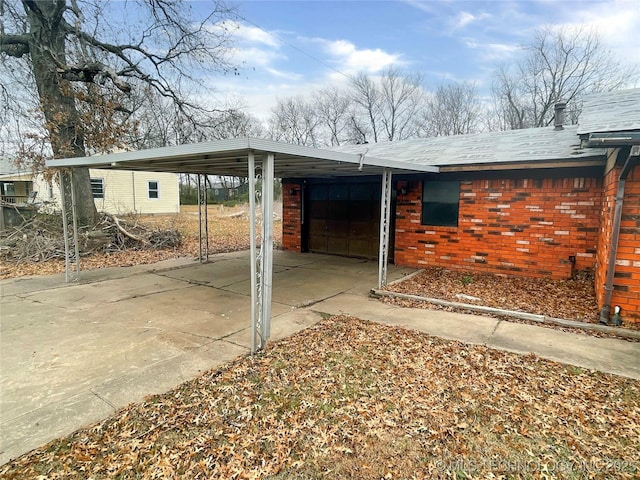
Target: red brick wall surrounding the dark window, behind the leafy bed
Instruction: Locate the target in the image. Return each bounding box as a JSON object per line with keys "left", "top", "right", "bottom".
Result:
{"left": 395, "top": 178, "right": 602, "bottom": 279}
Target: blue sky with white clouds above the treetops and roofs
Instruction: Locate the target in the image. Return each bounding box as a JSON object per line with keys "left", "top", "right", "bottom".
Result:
{"left": 192, "top": 0, "right": 640, "bottom": 120}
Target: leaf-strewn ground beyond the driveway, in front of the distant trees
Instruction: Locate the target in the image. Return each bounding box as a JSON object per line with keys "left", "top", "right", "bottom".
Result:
{"left": 0, "top": 205, "right": 282, "bottom": 279}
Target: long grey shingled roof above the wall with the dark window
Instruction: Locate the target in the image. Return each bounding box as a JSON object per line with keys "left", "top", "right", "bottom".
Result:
{"left": 335, "top": 125, "right": 605, "bottom": 167}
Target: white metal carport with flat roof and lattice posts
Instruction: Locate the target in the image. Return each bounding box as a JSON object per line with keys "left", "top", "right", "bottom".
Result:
{"left": 46, "top": 138, "right": 439, "bottom": 352}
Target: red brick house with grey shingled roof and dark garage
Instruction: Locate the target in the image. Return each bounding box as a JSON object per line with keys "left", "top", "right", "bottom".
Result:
{"left": 282, "top": 89, "right": 640, "bottom": 323}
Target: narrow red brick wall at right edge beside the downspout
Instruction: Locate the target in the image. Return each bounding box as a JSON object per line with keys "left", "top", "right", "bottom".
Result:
{"left": 596, "top": 166, "right": 640, "bottom": 323}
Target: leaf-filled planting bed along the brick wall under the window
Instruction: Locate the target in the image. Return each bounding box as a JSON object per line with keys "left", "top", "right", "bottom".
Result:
{"left": 386, "top": 267, "right": 599, "bottom": 323}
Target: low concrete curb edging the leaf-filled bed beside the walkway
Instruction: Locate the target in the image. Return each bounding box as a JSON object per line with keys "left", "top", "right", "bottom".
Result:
{"left": 371, "top": 286, "right": 640, "bottom": 340}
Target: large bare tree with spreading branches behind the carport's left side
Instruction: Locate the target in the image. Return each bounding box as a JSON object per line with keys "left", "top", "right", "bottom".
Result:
{"left": 0, "top": 0, "right": 238, "bottom": 224}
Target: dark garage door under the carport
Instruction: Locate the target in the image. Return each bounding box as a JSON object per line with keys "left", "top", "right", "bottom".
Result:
{"left": 308, "top": 182, "right": 380, "bottom": 258}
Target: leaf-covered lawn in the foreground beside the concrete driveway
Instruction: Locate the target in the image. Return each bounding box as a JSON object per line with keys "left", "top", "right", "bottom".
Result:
{"left": 0, "top": 316, "right": 640, "bottom": 479}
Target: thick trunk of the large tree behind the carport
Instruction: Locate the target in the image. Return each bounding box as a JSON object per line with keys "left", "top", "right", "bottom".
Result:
{"left": 25, "top": 1, "right": 98, "bottom": 225}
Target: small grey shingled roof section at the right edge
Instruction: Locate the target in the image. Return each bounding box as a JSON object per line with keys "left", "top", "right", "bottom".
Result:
{"left": 578, "top": 88, "right": 640, "bottom": 135}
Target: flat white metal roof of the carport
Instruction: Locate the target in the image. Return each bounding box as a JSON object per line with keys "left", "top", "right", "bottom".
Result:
{"left": 46, "top": 138, "right": 439, "bottom": 178}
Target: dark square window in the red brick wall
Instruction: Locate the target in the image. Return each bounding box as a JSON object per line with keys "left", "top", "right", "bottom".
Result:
{"left": 422, "top": 181, "right": 460, "bottom": 227}
